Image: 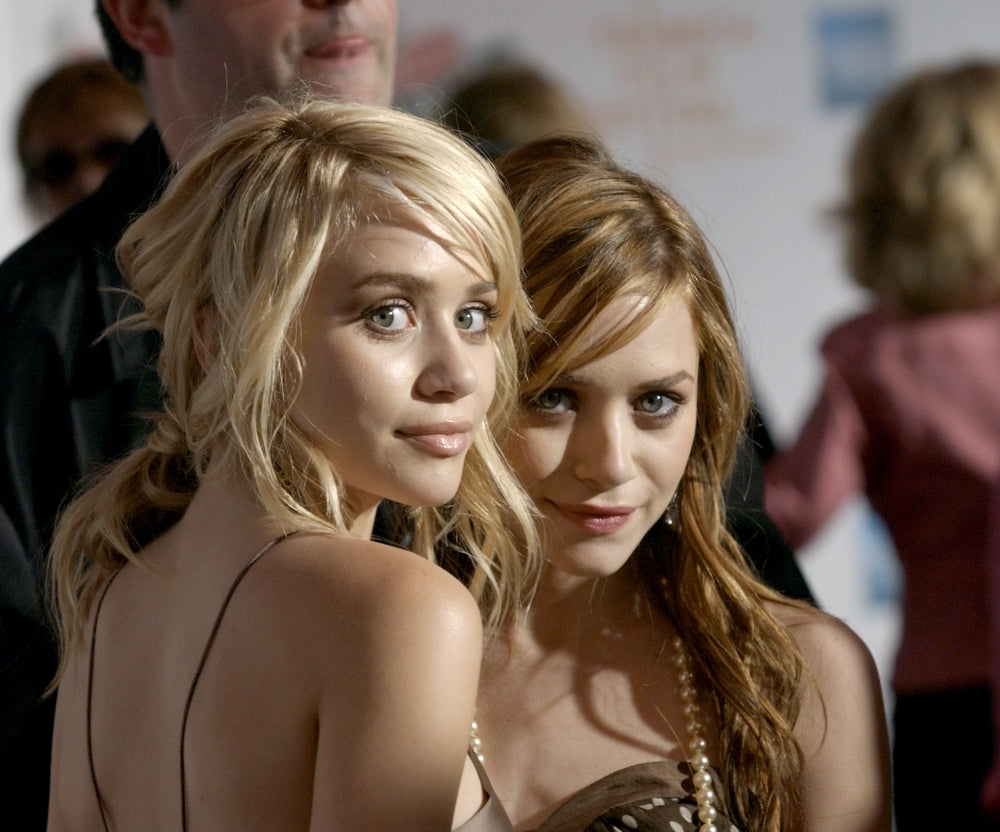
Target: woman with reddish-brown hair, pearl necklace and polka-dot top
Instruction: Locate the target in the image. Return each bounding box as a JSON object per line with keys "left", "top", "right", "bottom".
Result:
{"left": 478, "top": 137, "right": 890, "bottom": 832}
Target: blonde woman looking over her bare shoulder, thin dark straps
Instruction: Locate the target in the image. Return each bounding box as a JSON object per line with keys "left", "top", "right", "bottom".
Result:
{"left": 49, "top": 94, "right": 534, "bottom": 832}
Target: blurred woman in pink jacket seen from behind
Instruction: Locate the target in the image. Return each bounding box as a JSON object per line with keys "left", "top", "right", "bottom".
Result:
{"left": 766, "top": 63, "right": 1000, "bottom": 832}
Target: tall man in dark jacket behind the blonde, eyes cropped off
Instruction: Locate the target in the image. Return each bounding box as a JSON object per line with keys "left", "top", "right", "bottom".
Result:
{"left": 0, "top": 0, "right": 396, "bottom": 829}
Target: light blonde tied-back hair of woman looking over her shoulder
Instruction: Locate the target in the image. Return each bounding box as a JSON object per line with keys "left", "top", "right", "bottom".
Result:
{"left": 50, "top": 98, "right": 537, "bottom": 668}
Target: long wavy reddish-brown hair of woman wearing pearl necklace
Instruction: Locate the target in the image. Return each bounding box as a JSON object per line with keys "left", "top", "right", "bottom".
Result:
{"left": 498, "top": 137, "right": 803, "bottom": 830}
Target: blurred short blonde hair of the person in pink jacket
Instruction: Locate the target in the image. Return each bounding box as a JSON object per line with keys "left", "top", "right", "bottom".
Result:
{"left": 840, "top": 62, "right": 1000, "bottom": 315}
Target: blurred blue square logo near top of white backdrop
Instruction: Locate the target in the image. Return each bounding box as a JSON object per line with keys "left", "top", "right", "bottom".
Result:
{"left": 816, "top": 8, "right": 895, "bottom": 107}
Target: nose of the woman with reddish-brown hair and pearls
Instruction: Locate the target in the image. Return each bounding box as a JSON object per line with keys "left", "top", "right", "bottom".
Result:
{"left": 571, "top": 409, "right": 635, "bottom": 490}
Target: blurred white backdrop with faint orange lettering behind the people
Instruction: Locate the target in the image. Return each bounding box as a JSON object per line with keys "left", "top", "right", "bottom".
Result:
{"left": 0, "top": 0, "right": 1000, "bottom": 704}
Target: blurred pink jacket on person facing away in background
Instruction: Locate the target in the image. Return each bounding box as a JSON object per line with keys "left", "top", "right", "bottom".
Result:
{"left": 766, "top": 308, "right": 1000, "bottom": 693}
